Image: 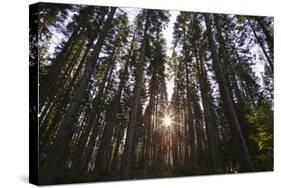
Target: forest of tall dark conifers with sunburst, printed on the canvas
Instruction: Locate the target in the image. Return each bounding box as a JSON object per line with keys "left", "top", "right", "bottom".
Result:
{"left": 29, "top": 3, "right": 274, "bottom": 184}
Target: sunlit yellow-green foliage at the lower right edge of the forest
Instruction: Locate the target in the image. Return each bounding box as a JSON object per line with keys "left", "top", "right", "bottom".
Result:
{"left": 247, "top": 100, "right": 273, "bottom": 170}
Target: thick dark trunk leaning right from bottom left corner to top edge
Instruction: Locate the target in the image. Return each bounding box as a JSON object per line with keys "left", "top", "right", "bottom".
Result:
{"left": 41, "top": 8, "right": 116, "bottom": 182}
